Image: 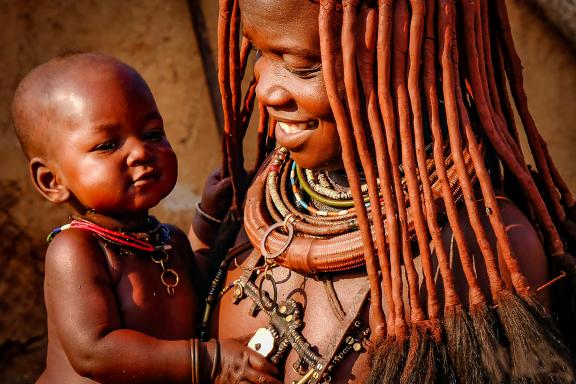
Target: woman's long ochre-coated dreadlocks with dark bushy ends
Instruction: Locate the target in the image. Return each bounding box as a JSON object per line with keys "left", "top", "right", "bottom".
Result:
{"left": 219, "top": 0, "right": 575, "bottom": 383}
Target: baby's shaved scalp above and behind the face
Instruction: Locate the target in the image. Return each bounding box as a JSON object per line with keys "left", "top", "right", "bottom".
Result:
{"left": 11, "top": 53, "right": 143, "bottom": 159}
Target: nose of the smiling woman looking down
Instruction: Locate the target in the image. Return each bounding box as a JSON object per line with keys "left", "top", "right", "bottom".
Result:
{"left": 254, "top": 57, "right": 293, "bottom": 109}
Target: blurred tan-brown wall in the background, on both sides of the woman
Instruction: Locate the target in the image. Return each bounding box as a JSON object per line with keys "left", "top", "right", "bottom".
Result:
{"left": 0, "top": 0, "right": 576, "bottom": 383}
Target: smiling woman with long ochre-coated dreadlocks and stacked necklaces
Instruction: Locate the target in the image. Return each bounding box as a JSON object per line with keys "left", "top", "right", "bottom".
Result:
{"left": 194, "top": 0, "right": 574, "bottom": 383}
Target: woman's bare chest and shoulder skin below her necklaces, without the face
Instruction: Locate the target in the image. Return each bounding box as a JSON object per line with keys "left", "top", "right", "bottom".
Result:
{"left": 213, "top": 198, "right": 548, "bottom": 383}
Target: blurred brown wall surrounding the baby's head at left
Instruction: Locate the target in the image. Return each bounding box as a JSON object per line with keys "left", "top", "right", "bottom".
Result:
{"left": 0, "top": 0, "right": 220, "bottom": 383}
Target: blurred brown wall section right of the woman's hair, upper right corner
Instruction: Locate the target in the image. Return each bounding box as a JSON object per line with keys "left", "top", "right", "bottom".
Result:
{"left": 506, "top": 0, "right": 576, "bottom": 191}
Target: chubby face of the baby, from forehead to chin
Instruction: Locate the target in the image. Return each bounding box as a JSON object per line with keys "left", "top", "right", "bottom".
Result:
{"left": 49, "top": 68, "right": 177, "bottom": 216}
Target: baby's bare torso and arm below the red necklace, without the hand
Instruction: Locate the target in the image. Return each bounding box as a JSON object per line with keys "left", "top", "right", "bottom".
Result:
{"left": 38, "top": 224, "right": 199, "bottom": 383}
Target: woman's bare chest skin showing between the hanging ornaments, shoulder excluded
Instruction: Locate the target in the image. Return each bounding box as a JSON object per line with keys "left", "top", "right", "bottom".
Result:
{"left": 215, "top": 250, "right": 369, "bottom": 383}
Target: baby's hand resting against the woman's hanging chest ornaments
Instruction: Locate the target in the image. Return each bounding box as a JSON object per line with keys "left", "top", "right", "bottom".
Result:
{"left": 214, "top": 339, "right": 282, "bottom": 384}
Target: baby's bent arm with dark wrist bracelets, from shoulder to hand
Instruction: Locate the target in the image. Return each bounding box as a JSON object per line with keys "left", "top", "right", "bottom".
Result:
{"left": 45, "top": 229, "right": 279, "bottom": 383}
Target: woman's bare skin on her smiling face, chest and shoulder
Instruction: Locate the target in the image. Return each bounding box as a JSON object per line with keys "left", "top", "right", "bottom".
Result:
{"left": 187, "top": 0, "right": 548, "bottom": 383}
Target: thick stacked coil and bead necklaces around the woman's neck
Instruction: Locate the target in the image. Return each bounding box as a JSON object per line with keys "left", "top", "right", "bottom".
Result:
{"left": 244, "top": 147, "right": 476, "bottom": 274}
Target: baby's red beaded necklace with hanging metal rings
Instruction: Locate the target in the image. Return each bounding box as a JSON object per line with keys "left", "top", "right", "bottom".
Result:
{"left": 46, "top": 216, "right": 180, "bottom": 296}
